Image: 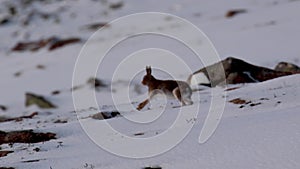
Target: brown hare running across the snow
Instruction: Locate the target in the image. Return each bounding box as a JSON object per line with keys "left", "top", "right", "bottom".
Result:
{"left": 137, "top": 66, "right": 193, "bottom": 110}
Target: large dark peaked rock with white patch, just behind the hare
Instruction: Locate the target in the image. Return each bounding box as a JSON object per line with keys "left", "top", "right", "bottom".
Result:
{"left": 187, "top": 57, "right": 292, "bottom": 87}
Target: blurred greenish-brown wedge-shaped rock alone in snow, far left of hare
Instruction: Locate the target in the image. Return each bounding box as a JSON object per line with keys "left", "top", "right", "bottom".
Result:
{"left": 25, "top": 93, "right": 56, "bottom": 109}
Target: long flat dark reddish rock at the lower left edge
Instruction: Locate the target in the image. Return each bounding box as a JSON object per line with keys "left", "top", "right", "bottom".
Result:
{"left": 0, "top": 130, "right": 56, "bottom": 145}
